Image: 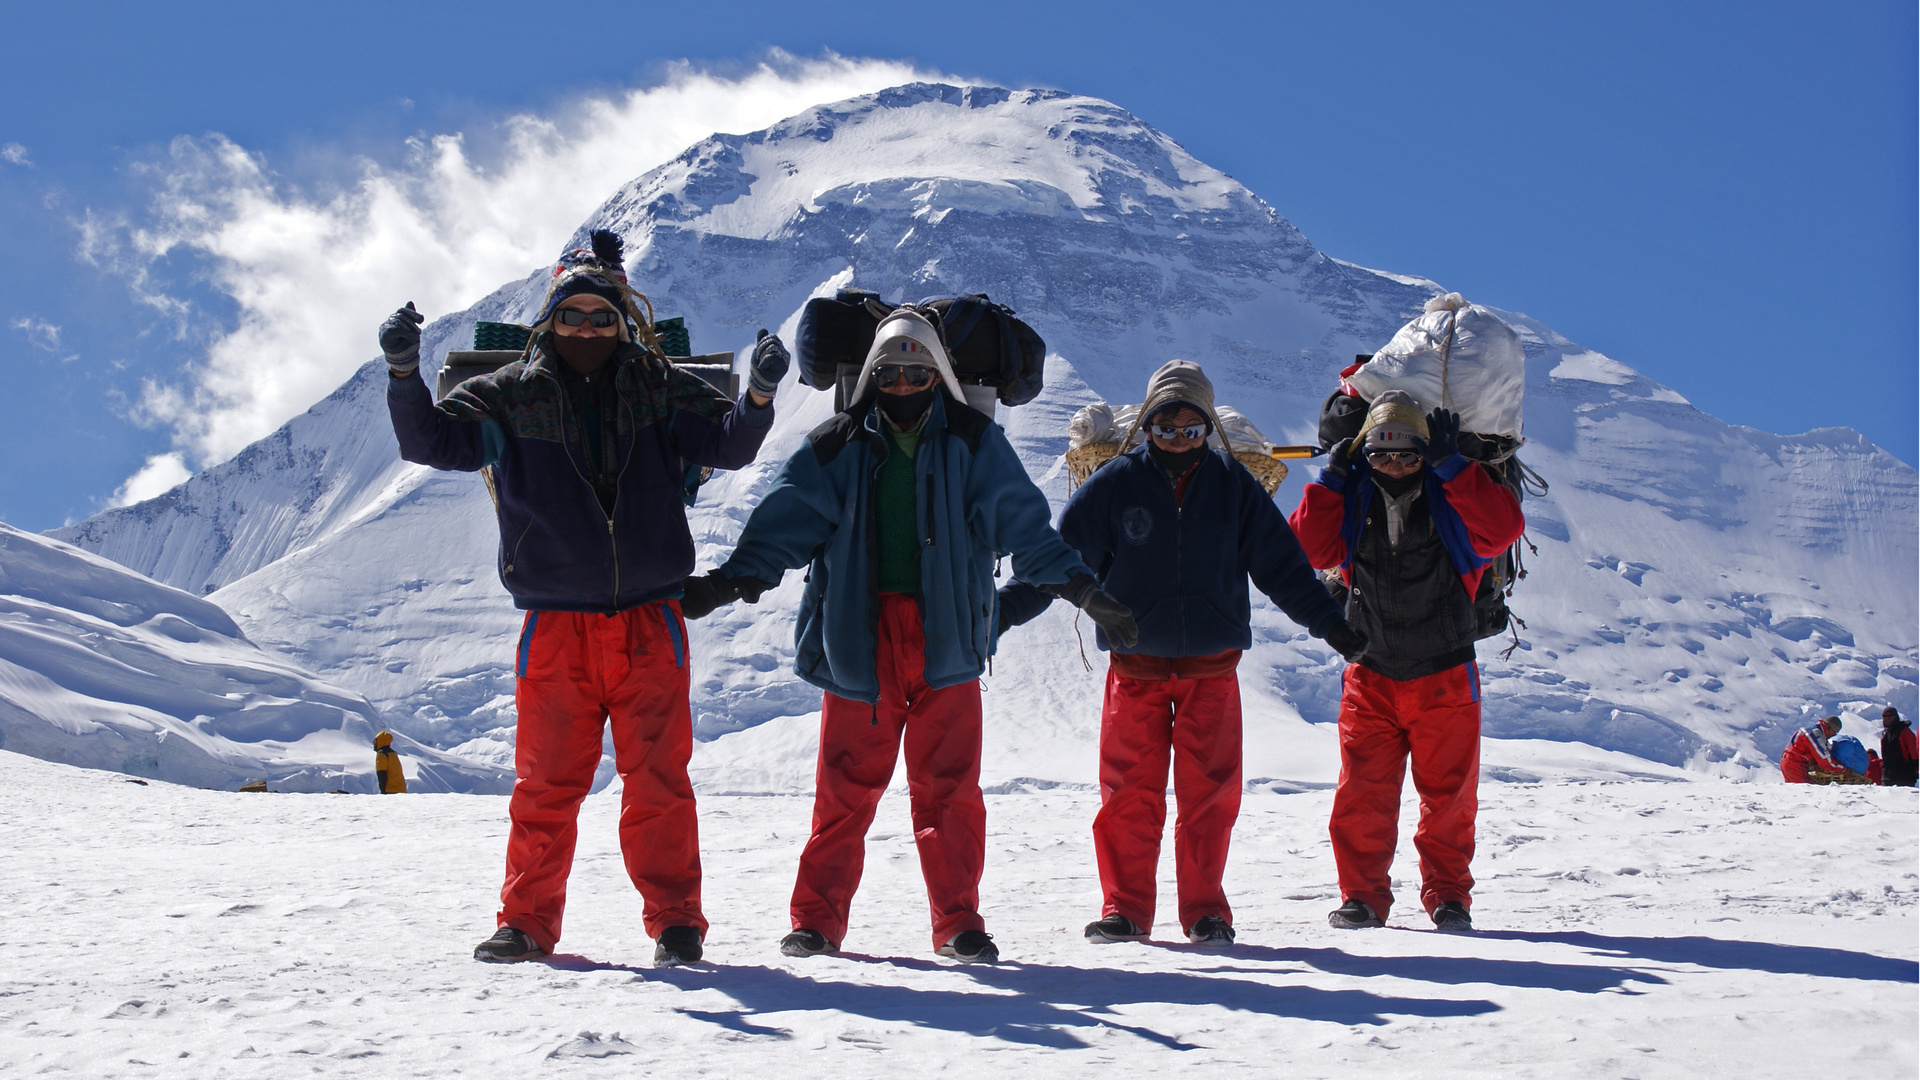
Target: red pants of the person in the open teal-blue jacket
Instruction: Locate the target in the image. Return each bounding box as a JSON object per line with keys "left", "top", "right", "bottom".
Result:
{"left": 791, "top": 592, "right": 987, "bottom": 949}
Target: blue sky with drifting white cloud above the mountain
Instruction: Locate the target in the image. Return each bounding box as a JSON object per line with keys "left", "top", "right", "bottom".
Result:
{"left": 0, "top": 0, "right": 1920, "bottom": 528}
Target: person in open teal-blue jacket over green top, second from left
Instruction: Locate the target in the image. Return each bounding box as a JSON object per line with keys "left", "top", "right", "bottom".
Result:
{"left": 685, "top": 309, "right": 1135, "bottom": 963}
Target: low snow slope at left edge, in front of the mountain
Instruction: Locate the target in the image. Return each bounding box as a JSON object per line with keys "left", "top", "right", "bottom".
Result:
{"left": 0, "top": 525, "right": 513, "bottom": 792}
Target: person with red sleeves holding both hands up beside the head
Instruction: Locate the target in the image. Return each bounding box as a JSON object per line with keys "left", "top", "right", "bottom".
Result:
{"left": 1292, "top": 390, "right": 1526, "bottom": 932}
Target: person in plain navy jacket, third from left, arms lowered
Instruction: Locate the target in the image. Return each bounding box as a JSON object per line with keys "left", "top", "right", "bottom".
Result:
{"left": 1000, "top": 359, "right": 1365, "bottom": 945}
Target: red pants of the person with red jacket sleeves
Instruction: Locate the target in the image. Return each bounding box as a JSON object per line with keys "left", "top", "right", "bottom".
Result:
{"left": 1329, "top": 663, "right": 1480, "bottom": 919}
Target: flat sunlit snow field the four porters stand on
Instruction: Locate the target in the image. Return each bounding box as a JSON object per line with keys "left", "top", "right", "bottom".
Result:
{"left": 0, "top": 753, "right": 1920, "bottom": 1078}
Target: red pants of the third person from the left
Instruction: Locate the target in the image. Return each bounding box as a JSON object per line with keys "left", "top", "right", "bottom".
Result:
{"left": 1092, "top": 669, "right": 1240, "bottom": 930}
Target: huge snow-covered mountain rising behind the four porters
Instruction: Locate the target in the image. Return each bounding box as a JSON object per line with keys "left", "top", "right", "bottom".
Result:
{"left": 45, "top": 85, "right": 1920, "bottom": 790}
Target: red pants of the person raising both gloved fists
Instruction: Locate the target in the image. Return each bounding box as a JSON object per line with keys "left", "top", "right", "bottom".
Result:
{"left": 499, "top": 600, "right": 707, "bottom": 951}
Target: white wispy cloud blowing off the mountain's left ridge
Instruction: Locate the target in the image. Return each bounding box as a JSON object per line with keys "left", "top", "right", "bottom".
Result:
{"left": 81, "top": 54, "right": 931, "bottom": 470}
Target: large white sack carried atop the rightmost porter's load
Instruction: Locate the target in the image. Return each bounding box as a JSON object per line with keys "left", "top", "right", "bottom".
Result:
{"left": 1346, "top": 292, "right": 1526, "bottom": 440}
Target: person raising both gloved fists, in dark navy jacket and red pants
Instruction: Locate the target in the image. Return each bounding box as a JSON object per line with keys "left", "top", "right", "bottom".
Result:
{"left": 380, "top": 231, "right": 787, "bottom": 967}
